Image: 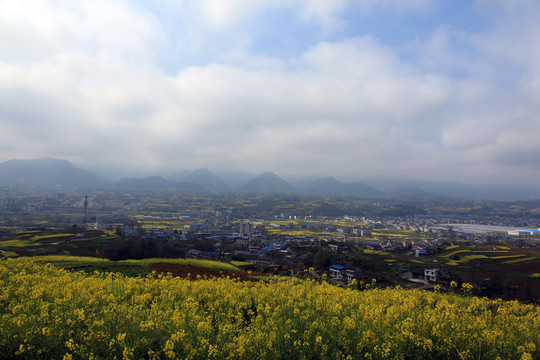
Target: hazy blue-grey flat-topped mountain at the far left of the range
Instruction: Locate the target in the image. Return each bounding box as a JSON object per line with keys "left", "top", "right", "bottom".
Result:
{"left": 0, "top": 158, "right": 111, "bottom": 191}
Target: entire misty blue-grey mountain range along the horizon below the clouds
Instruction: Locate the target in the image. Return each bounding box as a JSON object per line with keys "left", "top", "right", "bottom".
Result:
{"left": 0, "top": 158, "right": 540, "bottom": 200}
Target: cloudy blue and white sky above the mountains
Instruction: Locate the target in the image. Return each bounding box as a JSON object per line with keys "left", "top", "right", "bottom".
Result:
{"left": 0, "top": 0, "right": 540, "bottom": 186}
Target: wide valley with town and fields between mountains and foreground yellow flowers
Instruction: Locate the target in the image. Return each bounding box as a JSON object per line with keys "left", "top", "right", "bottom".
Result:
{"left": 0, "top": 186, "right": 540, "bottom": 302}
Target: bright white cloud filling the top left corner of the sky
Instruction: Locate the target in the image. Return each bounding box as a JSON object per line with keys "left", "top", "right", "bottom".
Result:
{"left": 0, "top": 0, "right": 164, "bottom": 62}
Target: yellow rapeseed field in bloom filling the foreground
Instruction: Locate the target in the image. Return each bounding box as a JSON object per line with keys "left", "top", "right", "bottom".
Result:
{"left": 0, "top": 259, "right": 540, "bottom": 359}
